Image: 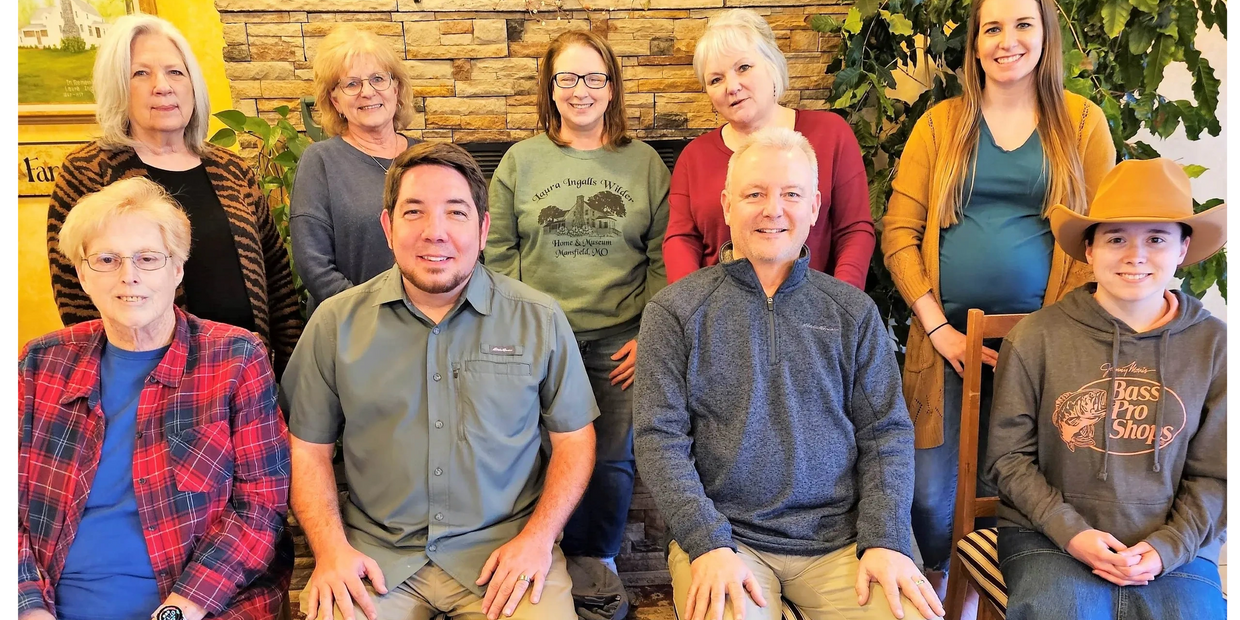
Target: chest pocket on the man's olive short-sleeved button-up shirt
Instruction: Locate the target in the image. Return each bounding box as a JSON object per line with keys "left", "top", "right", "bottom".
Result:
{"left": 453, "top": 360, "right": 538, "bottom": 440}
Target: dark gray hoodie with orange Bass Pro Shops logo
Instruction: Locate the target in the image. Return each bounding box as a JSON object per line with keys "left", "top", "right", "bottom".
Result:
{"left": 986, "top": 284, "right": 1231, "bottom": 572}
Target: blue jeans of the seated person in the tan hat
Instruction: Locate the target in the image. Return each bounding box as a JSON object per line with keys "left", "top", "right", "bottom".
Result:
{"left": 999, "top": 527, "right": 1228, "bottom": 620}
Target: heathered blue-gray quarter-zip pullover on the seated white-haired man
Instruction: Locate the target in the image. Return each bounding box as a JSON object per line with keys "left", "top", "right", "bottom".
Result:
{"left": 634, "top": 244, "right": 913, "bottom": 558}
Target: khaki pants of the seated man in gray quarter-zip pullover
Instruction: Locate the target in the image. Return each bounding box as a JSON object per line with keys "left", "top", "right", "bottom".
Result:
{"left": 667, "top": 541, "right": 923, "bottom": 620}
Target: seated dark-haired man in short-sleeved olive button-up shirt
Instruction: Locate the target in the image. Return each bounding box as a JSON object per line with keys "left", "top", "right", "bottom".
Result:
{"left": 290, "top": 144, "right": 598, "bottom": 620}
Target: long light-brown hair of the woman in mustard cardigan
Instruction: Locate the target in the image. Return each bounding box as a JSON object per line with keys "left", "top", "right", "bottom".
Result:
{"left": 930, "top": 0, "right": 1089, "bottom": 228}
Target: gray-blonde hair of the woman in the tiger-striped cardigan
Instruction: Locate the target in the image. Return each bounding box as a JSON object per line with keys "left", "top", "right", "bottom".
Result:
{"left": 92, "top": 14, "right": 211, "bottom": 155}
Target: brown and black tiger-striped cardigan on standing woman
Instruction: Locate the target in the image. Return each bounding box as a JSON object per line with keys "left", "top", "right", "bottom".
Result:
{"left": 47, "top": 143, "right": 304, "bottom": 377}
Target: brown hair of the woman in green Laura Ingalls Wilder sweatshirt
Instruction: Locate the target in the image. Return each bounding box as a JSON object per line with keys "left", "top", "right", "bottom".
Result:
{"left": 538, "top": 30, "right": 632, "bottom": 149}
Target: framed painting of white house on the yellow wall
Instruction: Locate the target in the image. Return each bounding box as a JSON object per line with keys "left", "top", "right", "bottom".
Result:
{"left": 12, "top": 0, "right": 155, "bottom": 123}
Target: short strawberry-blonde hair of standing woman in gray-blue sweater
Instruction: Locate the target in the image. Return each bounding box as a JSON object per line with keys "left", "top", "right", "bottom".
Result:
{"left": 314, "top": 26, "right": 415, "bottom": 135}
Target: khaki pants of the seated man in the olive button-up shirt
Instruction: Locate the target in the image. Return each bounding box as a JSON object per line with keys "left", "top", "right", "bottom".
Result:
{"left": 317, "top": 546, "right": 577, "bottom": 620}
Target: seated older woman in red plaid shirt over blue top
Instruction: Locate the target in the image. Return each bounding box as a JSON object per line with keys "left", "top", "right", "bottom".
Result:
{"left": 14, "top": 177, "right": 291, "bottom": 620}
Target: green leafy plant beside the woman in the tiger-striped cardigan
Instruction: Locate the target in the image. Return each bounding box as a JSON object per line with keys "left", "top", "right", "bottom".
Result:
{"left": 211, "top": 105, "right": 311, "bottom": 300}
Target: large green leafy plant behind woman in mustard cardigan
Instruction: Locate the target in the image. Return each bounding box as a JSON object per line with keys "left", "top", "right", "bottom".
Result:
{"left": 810, "top": 0, "right": 1231, "bottom": 354}
